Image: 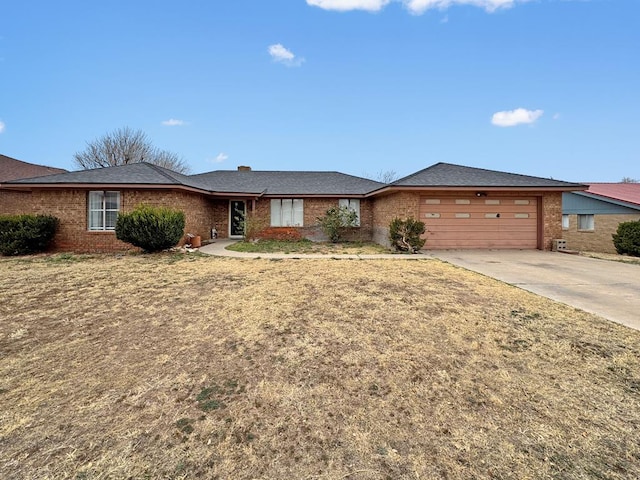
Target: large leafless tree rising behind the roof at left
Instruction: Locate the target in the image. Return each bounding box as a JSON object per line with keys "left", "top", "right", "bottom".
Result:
{"left": 73, "top": 127, "right": 189, "bottom": 173}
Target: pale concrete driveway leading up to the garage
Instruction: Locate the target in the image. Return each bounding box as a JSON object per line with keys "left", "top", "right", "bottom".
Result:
{"left": 428, "top": 250, "right": 640, "bottom": 330}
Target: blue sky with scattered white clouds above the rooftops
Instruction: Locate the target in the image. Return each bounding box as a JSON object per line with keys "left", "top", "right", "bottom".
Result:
{"left": 0, "top": 0, "right": 640, "bottom": 182}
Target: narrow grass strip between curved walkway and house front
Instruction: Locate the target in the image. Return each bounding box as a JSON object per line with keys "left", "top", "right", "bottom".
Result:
{"left": 227, "top": 239, "right": 392, "bottom": 255}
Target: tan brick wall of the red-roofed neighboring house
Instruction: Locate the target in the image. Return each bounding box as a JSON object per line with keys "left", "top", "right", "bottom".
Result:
{"left": 559, "top": 212, "right": 640, "bottom": 253}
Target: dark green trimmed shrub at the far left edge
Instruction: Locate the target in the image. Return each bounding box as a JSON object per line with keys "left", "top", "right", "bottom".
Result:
{"left": 0, "top": 215, "right": 59, "bottom": 255}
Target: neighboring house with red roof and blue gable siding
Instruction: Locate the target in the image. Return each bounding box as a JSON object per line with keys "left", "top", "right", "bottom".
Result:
{"left": 562, "top": 183, "right": 640, "bottom": 253}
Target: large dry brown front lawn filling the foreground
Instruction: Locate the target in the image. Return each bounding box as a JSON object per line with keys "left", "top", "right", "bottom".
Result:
{"left": 0, "top": 255, "right": 640, "bottom": 480}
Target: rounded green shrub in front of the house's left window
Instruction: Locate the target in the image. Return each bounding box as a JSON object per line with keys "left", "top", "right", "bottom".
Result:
{"left": 116, "top": 205, "right": 185, "bottom": 252}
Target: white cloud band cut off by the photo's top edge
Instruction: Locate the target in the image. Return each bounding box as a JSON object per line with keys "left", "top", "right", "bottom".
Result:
{"left": 307, "top": 0, "right": 529, "bottom": 15}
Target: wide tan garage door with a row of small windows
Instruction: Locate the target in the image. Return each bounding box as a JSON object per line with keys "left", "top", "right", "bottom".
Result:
{"left": 420, "top": 197, "right": 538, "bottom": 249}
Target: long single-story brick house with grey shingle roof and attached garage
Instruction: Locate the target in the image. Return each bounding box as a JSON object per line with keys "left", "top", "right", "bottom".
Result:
{"left": 0, "top": 163, "right": 586, "bottom": 252}
